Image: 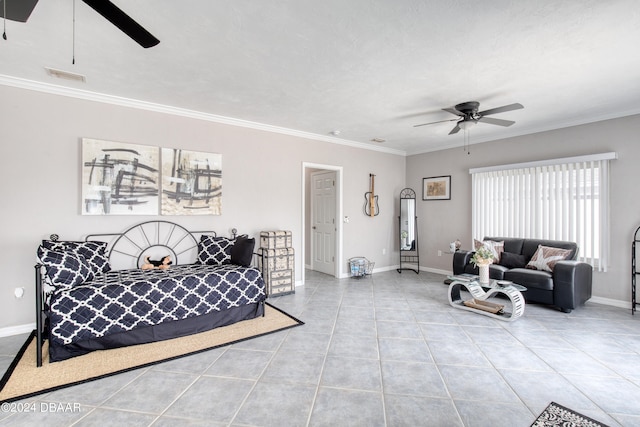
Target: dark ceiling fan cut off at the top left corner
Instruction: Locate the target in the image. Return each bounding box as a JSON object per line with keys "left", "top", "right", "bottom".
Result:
{"left": 0, "top": 0, "right": 160, "bottom": 48}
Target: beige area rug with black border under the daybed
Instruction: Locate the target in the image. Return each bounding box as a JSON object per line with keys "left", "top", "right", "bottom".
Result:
{"left": 0, "top": 304, "right": 304, "bottom": 403}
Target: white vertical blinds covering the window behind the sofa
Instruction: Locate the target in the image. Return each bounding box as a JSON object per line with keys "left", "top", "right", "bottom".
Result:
{"left": 470, "top": 153, "right": 616, "bottom": 271}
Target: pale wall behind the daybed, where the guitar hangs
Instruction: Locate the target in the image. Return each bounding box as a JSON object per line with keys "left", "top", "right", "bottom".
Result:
{"left": 0, "top": 86, "right": 405, "bottom": 329}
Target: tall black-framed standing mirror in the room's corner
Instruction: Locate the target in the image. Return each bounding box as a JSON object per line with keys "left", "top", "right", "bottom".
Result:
{"left": 398, "top": 188, "right": 420, "bottom": 273}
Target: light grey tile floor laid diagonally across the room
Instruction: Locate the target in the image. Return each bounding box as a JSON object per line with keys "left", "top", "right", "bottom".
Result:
{"left": 0, "top": 271, "right": 640, "bottom": 427}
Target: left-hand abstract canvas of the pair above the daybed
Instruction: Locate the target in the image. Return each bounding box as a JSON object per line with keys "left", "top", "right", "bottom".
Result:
{"left": 82, "top": 138, "right": 160, "bottom": 215}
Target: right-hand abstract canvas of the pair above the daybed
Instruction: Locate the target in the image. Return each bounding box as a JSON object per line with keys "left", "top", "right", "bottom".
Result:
{"left": 161, "top": 148, "right": 222, "bottom": 215}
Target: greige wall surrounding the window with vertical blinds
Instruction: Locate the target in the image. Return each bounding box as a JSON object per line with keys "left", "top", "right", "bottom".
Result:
{"left": 407, "top": 115, "right": 640, "bottom": 308}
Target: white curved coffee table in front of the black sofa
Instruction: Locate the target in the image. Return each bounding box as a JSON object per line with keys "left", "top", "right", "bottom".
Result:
{"left": 449, "top": 276, "right": 527, "bottom": 322}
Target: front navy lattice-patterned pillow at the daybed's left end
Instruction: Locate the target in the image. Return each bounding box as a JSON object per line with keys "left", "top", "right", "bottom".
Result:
{"left": 38, "top": 246, "right": 94, "bottom": 288}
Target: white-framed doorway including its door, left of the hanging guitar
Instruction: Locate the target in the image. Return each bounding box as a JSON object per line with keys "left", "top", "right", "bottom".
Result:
{"left": 302, "top": 163, "right": 342, "bottom": 284}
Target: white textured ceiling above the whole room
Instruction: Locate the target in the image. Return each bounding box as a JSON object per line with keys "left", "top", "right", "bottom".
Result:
{"left": 0, "top": 0, "right": 640, "bottom": 154}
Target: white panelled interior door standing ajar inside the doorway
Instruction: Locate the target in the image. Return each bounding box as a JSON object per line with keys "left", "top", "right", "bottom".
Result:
{"left": 311, "top": 171, "right": 337, "bottom": 276}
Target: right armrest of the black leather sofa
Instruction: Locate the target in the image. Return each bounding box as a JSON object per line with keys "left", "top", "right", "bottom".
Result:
{"left": 553, "top": 261, "right": 593, "bottom": 312}
